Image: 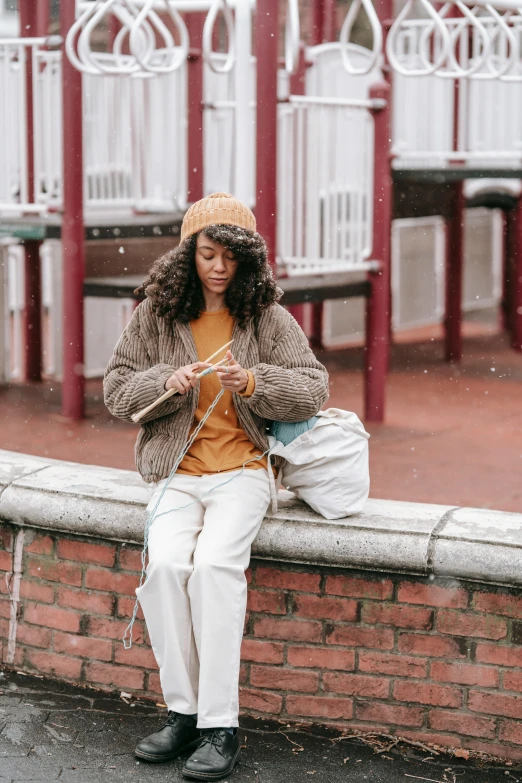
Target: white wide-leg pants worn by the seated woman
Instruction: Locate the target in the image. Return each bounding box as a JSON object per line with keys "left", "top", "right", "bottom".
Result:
{"left": 136, "top": 469, "right": 270, "bottom": 728}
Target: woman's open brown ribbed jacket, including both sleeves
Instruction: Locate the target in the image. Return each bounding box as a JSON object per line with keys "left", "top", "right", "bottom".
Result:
{"left": 103, "top": 299, "right": 328, "bottom": 482}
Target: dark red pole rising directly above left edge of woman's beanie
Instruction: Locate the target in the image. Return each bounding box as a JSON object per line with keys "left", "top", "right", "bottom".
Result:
{"left": 186, "top": 12, "right": 205, "bottom": 203}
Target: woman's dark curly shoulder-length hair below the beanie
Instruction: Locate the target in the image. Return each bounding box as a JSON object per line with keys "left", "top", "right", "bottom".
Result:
{"left": 135, "top": 224, "right": 283, "bottom": 329}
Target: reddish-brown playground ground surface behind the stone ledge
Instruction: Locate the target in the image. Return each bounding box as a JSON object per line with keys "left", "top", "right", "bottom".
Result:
{"left": 0, "top": 324, "right": 522, "bottom": 512}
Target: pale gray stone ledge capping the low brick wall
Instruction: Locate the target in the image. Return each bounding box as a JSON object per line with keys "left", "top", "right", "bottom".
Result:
{"left": 0, "top": 450, "right": 522, "bottom": 586}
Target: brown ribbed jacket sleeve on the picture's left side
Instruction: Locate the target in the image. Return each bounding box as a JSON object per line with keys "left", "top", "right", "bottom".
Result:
{"left": 103, "top": 305, "right": 190, "bottom": 423}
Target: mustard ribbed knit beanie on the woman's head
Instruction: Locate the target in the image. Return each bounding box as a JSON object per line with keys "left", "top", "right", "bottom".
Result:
{"left": 181, "top": 193, "right": 256, "bottom": 242}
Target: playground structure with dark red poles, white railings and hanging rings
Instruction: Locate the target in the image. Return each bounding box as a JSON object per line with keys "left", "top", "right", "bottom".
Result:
{"left": 0, "top": 0, "right": 522, "bottom": 421}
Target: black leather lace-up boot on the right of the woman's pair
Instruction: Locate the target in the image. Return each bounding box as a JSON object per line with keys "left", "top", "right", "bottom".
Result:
{"left": 181, "top": 729, "right": 239, "bottom": 780}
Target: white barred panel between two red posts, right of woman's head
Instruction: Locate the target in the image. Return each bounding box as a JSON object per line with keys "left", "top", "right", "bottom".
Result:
{"left": 278, "top": 96, "right": 374, "bottom": 276}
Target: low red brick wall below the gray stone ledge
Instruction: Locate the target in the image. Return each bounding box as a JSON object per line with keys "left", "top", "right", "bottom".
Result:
{"left": 0, "top": 526, "right": 522, "bottom": 759}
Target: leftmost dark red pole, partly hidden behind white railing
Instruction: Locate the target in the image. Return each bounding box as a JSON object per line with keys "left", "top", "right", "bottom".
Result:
{"left": 20, "top": 0, "right": 42, "bottom": 381}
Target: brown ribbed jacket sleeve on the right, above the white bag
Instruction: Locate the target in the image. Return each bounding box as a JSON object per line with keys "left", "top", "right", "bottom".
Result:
{"left": 246, "top": 308, "right": 329, "bottom": 422}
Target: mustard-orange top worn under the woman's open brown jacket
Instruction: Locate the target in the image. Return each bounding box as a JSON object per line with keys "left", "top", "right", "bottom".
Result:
{"left": 178, "top": 310, "right": 267, "bottom": 476}
